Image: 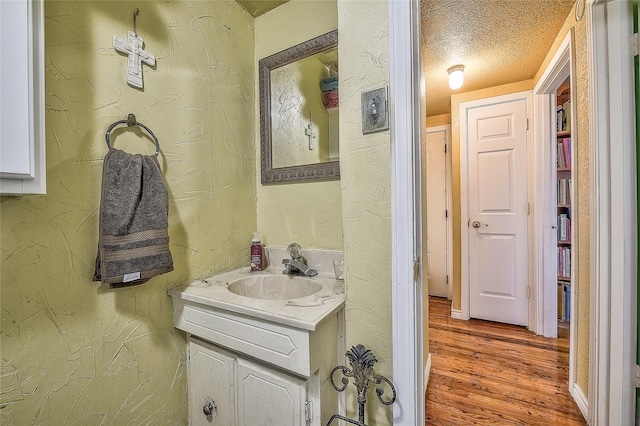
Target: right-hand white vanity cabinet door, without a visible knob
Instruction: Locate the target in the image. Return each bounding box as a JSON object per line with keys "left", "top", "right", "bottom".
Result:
{"left": 238, "top": 358, "right": 307, "bottom": 426}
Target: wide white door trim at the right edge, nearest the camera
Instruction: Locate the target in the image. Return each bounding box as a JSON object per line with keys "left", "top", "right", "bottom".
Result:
{"left": 585, "top": 0, "right": 638, "bottom": 425}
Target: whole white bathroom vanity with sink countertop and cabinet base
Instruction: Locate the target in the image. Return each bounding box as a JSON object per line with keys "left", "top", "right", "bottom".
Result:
{"left": 169, "top": 267, "right": 344, "bottom": 426}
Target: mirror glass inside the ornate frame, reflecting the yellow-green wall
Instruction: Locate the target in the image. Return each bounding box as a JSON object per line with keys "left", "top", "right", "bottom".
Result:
{"left": 271, "top": 48, "right": 339, "bottom": 168}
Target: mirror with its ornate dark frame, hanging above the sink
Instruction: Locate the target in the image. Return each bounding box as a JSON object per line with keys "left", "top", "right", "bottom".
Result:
{"left": 258, "top": 30, "right": 340, "bottom": 184}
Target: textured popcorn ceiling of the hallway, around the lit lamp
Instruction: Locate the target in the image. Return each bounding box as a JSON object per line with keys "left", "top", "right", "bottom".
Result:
{"left": 420, "top": 0, "right": 575, "bottom": 116}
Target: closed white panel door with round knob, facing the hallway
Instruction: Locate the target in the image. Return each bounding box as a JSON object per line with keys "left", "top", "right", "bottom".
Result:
{"left": 460, "top": 93, "right": 531, "bottom": 326}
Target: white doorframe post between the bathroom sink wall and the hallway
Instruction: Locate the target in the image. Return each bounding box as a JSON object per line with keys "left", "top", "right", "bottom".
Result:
{"left": 388, "top": 0, "right": 428, "bottom": 425}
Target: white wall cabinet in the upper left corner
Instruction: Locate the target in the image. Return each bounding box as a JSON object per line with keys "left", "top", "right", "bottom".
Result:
{"left": 0, "top": 0, "right": 46, "bottom": 195}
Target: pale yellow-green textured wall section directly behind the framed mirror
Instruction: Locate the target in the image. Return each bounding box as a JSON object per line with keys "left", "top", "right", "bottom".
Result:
{"left": 255, "top": 0, "right": 343, "bottom": 250}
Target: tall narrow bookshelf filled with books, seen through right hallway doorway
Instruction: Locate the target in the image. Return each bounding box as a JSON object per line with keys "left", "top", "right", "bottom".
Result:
{"left": 556, "top": 79, "right": 573, "bottom": 321}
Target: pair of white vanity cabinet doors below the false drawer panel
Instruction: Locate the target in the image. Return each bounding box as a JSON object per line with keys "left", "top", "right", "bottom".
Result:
{"left": 189, "top": 336, "right": 314, "bottom": 426}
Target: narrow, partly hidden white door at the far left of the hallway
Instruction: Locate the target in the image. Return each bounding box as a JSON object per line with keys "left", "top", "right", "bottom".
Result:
{"left": 424, "top": 126, "right": 450, "bottom": 297}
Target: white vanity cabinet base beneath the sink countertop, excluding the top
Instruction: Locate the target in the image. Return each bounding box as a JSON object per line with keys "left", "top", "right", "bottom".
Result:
{"left": 174, "top": 298, "right": 344, "bottom": 426}
